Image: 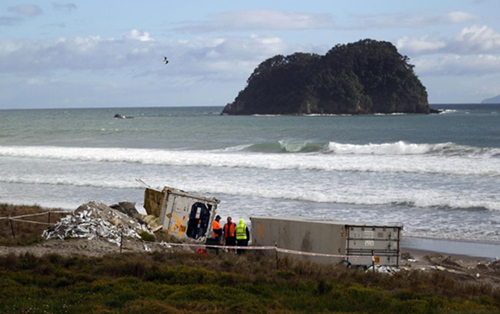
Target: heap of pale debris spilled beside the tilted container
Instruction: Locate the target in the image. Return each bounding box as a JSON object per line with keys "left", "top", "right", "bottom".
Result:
{"left": 42, "top": 202, "right": 151, "bottom": 245}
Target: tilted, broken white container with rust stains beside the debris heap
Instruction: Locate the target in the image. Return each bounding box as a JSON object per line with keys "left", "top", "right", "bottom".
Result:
{"left": 144, "top": 186, "right": 220, "bottom": 241}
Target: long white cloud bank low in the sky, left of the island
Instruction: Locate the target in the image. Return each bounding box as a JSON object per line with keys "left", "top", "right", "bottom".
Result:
{"left": 0, "top": 30, "right": 296, "bottom": 84}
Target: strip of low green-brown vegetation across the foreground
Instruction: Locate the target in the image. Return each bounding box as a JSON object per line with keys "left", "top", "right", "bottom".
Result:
{"left": 0, "top": 253, "right": 500, "bottom": 313}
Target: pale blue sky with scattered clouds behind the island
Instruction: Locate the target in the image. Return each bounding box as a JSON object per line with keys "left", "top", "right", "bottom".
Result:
{"left": 0, "top": 0, "right": 500, "bottom": 109}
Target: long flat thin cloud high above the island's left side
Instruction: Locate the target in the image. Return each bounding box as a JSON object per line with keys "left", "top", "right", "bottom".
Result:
{"left": 176, "top": 10, "right": 335, "bottom": 32}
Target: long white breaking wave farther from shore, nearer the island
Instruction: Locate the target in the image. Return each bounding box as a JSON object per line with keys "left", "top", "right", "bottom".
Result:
{"left": 0, "top": 143, "right": 500, "bottom": 176}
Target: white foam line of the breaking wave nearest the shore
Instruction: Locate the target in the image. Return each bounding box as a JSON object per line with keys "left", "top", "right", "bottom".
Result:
{"left": 0, "top": 176, "right": 500, "bottom": 211}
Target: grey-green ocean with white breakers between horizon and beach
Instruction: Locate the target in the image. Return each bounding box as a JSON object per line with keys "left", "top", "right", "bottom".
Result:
{"left": 0, "top": 104, "right": 500, "bottom": 251}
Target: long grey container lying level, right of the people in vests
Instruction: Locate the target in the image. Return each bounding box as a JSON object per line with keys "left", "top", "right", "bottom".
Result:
{"left": 250, "top": 216, "right": 403, "bottom": 267}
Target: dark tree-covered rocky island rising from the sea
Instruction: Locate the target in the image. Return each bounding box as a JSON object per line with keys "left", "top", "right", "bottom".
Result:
{"left": 221, "top": 39, "right": 430, "bottom": 115}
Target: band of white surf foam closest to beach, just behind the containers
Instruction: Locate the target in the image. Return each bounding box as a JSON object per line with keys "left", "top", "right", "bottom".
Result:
{"left": 0, "top": 169, "right": 500, "bottom": 211}
